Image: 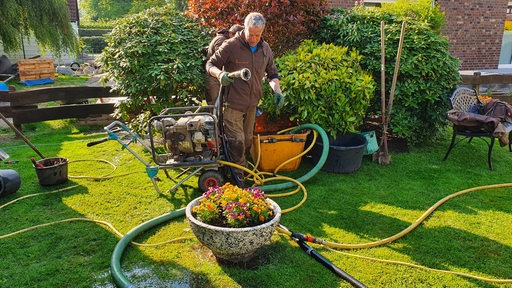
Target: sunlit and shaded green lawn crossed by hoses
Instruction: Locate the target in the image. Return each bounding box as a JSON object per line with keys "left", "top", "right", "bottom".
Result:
{"left": 0, "top": 121, "right": 512, "bottom": 287}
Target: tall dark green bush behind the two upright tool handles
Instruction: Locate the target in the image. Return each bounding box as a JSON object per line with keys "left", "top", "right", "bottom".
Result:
{"left": 317, "top": 7, "right": 460, "bottom": 145}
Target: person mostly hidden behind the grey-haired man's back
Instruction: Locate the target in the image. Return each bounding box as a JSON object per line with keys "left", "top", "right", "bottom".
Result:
{"left": 205, "top": 24, "right": 244, "bottom": 105}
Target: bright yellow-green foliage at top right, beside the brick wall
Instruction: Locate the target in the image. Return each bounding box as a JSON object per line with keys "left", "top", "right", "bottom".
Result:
{"left": 381, "top": 0, "right": 446, "bottom": 33}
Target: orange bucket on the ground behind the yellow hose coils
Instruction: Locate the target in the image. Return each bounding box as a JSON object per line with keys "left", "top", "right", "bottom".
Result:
{"left": 251, "top": 132, "right": 309, "bottom": 172}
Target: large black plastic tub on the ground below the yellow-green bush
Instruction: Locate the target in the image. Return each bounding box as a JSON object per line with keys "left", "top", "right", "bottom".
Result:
{"left": 311, "top": 133, "right": 368, "bottom": 174}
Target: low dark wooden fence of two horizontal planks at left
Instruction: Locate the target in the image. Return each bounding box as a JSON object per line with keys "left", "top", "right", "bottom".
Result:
{"left": 0, "top": 86, "right": 119, "bottom": 131}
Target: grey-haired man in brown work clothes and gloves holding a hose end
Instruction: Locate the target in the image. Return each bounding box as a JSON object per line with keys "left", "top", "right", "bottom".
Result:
{"left": 206, "top": 12, "right": 284, "bottom": 186}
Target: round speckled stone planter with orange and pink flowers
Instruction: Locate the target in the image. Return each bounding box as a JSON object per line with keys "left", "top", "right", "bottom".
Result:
{"left": 185, "top": 183, "right": 281, "bottom": 262}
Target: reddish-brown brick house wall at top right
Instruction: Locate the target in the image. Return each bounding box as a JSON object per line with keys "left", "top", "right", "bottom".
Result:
{"left": 327, "top": 0, "right": 508, "bottom": 70}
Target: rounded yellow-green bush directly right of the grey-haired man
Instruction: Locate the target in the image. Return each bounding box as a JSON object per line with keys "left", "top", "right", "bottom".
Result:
{"left": 264, "top": 40, "right": 375, "bottom": 137}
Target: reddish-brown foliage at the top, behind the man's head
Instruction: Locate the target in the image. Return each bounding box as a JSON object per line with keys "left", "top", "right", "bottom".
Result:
{"left": 189, "top": 0, "right": 328, "bottom": 56}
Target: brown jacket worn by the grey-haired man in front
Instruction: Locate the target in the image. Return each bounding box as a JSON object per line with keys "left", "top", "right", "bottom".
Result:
{"left": 206, "top": 31, "right": 278, "bottom": 112}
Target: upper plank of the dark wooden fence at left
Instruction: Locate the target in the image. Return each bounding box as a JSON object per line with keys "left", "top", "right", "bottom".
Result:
{"left": 0, "top": 86, "right": 119, "bottom": 107}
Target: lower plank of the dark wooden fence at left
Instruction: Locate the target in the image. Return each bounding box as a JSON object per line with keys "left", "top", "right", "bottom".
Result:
{"left": 12, "top": 103, "right": 114, "bottom": 124}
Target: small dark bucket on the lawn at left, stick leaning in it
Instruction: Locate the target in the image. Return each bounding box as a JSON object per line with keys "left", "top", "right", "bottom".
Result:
{"left": 34, "top": 157, "right": 68, "bottom": 186}
